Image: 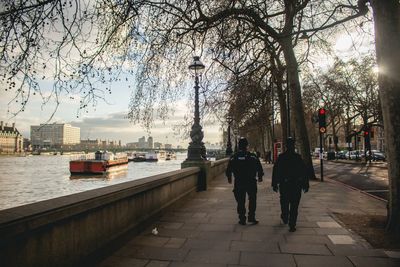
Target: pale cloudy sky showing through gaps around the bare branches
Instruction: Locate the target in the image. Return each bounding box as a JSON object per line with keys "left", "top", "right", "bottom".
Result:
{"left": 0, "top": 23, "right": 376, "bottom": 147}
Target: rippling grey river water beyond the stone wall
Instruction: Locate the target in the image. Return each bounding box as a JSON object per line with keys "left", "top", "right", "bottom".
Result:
{"left": 0, "top": 153, "right": 186, "bottom": 210}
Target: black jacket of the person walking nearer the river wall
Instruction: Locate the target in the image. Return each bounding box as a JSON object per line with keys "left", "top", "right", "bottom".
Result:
{"left": 225, "top": 151, "right": 264, "bottom": 184}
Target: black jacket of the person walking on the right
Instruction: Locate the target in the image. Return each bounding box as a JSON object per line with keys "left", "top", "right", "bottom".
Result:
{"left": 272, "top": 151, "right": 309, "bottom": 189}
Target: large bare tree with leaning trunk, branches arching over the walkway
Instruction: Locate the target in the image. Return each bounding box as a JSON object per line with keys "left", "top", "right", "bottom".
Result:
{"left": 0, "top": 0, "right": 365, "bottom": 182}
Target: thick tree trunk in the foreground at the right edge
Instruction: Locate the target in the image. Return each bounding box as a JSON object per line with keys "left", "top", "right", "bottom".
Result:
{"left": 370, "top": 0, "right": 400, "bottom": 239}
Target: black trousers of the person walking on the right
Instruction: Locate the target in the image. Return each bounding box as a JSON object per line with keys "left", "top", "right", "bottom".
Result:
{"left": 279, "top": 183, "right": 301, "bottom": 227}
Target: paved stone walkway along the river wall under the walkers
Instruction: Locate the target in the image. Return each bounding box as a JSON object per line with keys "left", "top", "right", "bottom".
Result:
{"left": 98, "top": 165, "right": 400, "bottom": 267}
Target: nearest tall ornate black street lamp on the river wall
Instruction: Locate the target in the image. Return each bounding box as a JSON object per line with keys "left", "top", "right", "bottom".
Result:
{"left": 187, "top": 56, "right": 206, "bottom": 160}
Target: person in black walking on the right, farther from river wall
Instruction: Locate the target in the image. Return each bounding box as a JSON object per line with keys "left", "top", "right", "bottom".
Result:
{"left": 272, "top": 137, "right": 309, "bottom": 232}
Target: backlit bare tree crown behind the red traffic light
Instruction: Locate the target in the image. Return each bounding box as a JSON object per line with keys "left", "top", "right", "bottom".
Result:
{"left": 304, "top": 56, "right": 382, "bottom": 153}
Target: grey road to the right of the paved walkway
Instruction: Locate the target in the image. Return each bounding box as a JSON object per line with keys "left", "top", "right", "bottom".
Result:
{"left": 314, "top": 160, "right": 389, "bottom": 200}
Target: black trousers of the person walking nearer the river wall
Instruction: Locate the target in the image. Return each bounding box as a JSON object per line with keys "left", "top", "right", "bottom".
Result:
{"left": 233, "top": 180, "right": 257, "bottom": 221}
